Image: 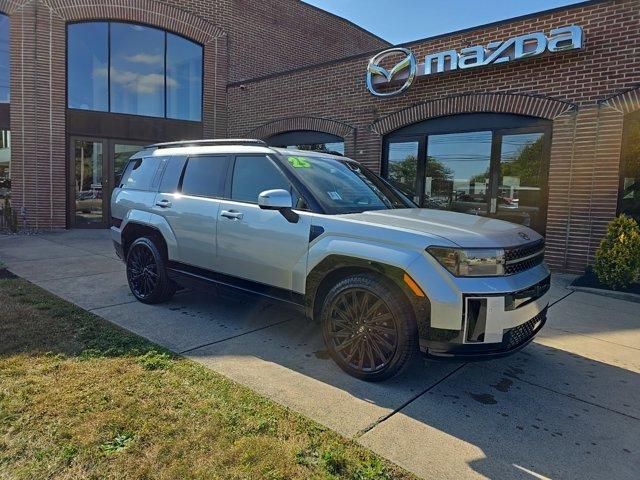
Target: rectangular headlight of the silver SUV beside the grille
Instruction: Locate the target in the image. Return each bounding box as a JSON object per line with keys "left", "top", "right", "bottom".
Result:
{"left": 427, "top": 247, "right": 504, "bottom": 277}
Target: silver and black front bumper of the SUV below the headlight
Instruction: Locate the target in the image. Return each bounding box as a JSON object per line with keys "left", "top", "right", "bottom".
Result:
{"left": 409, "top": 251, "right": 551, "bottom": 361}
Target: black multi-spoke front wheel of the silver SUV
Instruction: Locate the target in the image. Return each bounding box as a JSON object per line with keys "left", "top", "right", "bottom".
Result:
{"left": 320, "top": 273, "right": 418, "bottom": 382}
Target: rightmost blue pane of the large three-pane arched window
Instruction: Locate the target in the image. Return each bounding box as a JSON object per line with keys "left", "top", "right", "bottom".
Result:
{"left": 167, "top": 33, "right": 202, "bottom": 121}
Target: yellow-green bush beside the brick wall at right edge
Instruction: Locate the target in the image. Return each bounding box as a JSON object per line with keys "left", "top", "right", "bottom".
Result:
{"left": 594, "top": 215, "right": 640, "bottom": 290}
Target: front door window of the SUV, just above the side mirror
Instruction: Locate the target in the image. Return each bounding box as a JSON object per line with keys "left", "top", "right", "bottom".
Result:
{"left": 231, "top": 155, "right": 291, "bottom": 203}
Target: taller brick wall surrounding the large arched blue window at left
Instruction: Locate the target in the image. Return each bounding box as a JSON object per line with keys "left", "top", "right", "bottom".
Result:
{"left": 0, "top": 0, "right": 385, "bottom": 229}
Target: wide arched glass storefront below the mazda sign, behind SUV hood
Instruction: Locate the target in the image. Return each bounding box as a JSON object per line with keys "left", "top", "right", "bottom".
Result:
{"left": 382, "top": 113, "right": 551, "bottom": 235}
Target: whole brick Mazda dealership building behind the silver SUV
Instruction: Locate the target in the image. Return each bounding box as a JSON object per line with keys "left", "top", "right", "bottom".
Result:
{"left": 0, "top": 0, "right": 640, "bottom": 272}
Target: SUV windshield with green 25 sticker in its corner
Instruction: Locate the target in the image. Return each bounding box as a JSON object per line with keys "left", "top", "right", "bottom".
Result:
{"left": 284, "top": 154, "right": 415, "bottom": 214}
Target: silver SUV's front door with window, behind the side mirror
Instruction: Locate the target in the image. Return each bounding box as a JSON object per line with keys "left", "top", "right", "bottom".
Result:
{"left": 217, "top": 155, "right": 311, "bottom": 295}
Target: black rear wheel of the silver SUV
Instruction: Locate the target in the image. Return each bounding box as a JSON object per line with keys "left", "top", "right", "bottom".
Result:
{"left": 126, "top": 237, "right": 176, "bottom": 304}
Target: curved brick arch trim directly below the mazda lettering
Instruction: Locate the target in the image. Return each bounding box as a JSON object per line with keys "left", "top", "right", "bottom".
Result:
{"left": 369, "top": 93, "right": 578, "bottom": 135}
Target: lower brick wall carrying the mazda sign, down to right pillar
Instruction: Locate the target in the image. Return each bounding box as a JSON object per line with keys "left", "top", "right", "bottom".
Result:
{"left": 228, "top": 0, "right": 640, "bottom": 272}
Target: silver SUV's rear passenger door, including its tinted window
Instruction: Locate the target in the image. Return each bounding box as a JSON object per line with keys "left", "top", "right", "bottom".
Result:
{"left": 154, "top": 155, "right": 229, "bottom": 270}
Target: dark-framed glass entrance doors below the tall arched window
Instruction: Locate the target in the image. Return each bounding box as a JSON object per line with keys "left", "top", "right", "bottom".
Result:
{"left": 69, "top": 137, "right": 144, "bottom": 228}
